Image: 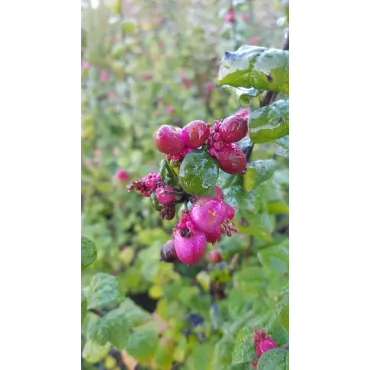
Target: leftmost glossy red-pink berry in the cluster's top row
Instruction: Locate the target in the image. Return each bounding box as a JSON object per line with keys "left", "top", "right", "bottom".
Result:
{"left": 154, "top": 125, "right": 184, "bottom": 154}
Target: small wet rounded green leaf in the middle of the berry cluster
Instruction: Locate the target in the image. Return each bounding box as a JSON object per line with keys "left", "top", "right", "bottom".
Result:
{"left": 179, "top": 149, "right": 219, "bottom": 196}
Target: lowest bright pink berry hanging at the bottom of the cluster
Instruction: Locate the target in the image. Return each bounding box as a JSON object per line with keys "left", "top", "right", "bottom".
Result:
{"left": 173, "top": 229, "right": 207, "bottom": 265}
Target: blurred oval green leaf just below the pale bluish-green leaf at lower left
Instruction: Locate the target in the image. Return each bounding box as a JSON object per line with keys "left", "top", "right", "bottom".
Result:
{"left": 103, "top": 308, "right": 130, "bottom": 350}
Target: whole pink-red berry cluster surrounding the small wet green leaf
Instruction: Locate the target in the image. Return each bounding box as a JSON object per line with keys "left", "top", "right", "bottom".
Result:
{"left": 128, "top": 112, "right": 248, "bottom": 265}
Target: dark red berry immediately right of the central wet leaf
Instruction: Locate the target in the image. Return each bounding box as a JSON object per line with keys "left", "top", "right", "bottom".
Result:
{"left": 216, "top": 144, "right": 247, "bottom": 175}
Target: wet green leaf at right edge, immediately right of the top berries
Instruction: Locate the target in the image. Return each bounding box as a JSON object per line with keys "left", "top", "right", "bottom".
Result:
{"left": 249, "top": 100, "right": 290, "bottom": 144}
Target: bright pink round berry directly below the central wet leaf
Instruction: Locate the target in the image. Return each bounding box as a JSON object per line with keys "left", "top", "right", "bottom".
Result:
{"left": 190, "top": 197, "right": 226, "bottom": 233}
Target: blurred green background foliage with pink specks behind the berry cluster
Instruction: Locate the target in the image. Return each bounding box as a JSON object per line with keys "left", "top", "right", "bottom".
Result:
{"left": 80, "top": 0, "right": 289, "bottom": 370}
